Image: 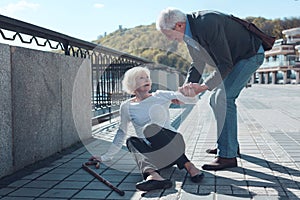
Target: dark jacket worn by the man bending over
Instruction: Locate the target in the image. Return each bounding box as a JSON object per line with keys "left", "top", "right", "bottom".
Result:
{"left": 186, "top": 11, "right": 262, "bottom": 90}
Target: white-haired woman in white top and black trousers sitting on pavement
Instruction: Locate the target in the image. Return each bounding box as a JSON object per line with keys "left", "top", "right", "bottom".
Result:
{"left": 98, "top": 67, "right": 204, "bottom": 191}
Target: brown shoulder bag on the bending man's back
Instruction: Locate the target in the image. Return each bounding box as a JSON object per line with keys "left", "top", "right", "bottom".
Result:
{"left": 230, "top": 15, "right": 275, "bottom": 51}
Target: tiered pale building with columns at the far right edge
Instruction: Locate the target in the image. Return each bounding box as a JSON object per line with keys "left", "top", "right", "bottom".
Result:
{"left": 253, "top": 27, "right": 300, "bottom": 84}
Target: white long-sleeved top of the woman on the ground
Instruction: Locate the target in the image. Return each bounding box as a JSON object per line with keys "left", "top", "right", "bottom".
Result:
{"left": 101, "top": 90, "right": 198, "bottom": 161}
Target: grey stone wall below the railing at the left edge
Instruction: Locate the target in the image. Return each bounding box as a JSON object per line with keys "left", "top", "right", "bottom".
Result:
{"left": 0, "top": 44, "right": 91, "bottom": 177}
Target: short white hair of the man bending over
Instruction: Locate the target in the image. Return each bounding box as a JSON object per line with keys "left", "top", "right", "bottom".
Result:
{"left": 156, "top": 7, "right": 186, "bottom": 31}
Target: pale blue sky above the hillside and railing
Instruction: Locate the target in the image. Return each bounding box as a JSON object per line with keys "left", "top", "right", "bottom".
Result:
{"left": 0, "top": 0, "right": 300, "bottom": 41}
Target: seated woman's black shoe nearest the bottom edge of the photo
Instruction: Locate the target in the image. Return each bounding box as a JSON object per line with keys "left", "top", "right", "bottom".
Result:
{"left": 135, "top": 179, "right": 172, "bottom": 191}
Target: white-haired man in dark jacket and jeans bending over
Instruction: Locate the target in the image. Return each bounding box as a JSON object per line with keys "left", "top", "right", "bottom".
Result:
{"left": 156, "top": 8, "right": 264, "bottom": 170}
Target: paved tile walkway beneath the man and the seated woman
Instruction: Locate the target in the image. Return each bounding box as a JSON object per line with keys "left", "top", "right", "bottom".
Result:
{"left": 0, "top": 85, "right": 300, "bottom": 200}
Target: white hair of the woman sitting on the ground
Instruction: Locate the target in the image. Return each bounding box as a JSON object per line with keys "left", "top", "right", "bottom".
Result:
{"left": 122, "top": 66, "right": 150, "bottom": 94}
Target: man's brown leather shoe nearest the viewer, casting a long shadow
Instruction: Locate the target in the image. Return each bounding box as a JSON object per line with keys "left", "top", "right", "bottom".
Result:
{"left": 202, "top": 157, "right": 237, "bottom": 170}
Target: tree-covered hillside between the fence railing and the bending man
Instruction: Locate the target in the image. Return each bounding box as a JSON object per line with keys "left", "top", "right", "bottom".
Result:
{"left": 93, "top": 24, "right": 191, "bottom": 71}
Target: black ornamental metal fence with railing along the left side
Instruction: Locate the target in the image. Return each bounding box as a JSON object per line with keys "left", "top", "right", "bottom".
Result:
{"left": 0, "top": 15, "right": 151, "bottom": 124}
